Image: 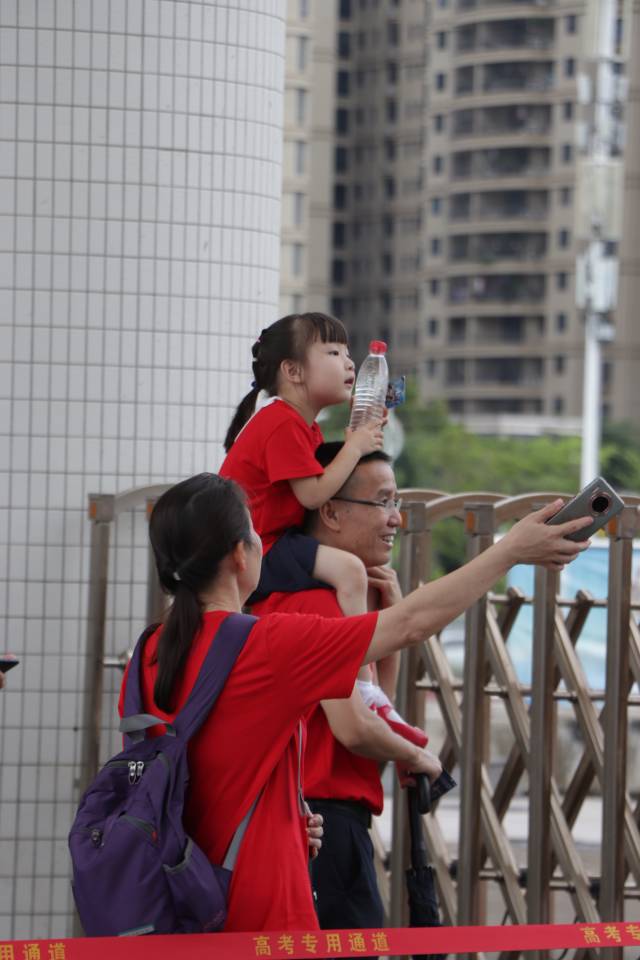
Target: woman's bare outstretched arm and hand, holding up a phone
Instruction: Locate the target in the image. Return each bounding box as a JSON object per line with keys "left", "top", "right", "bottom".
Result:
{"left": 363, "top": 500, "right": 590, "bottom": 663}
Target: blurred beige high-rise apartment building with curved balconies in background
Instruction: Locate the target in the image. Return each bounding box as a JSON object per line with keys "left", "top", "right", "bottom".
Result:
{"left": 281, "top": 0, "right": 640, "bottom": 429}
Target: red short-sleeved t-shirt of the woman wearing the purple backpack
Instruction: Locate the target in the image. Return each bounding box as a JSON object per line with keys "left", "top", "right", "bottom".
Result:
{"left": 119, "top": 611, "right": 376, "bottom": 931}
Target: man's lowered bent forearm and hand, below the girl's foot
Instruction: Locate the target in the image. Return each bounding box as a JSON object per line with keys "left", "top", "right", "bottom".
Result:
{"left": 322, "top": 688, "right": 437, "bottom": 774}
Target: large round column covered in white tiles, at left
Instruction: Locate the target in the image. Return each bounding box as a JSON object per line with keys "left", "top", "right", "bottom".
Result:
{"left": 0, "top": 0, "right": 285, "bottom": 939}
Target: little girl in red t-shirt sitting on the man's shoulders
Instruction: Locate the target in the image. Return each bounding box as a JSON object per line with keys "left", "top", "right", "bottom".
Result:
{"left": 220, "top": 313, "right": 382, "bottom": 616}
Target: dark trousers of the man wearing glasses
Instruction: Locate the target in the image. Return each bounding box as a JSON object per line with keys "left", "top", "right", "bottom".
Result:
{"left": 309, "top": 800, "right": 384, "bottom": 930}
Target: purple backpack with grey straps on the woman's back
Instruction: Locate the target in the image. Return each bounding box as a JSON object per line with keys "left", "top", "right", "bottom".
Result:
{"left": 69, "top": 613, "right": 257, "bottom": 937}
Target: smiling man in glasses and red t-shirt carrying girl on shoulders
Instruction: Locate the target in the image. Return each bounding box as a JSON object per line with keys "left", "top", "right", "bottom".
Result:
{"left": 252, "top": 443, "right": 442, "bottom": 929}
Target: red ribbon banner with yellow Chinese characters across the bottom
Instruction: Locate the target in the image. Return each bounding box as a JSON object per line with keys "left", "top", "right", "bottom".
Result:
{"left": 0, "top": 923, "right": 640, "bottom": 960}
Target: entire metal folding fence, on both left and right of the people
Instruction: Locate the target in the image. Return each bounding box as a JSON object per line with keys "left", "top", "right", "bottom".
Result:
{"left": 76, "top": 485, "right": 640, "bottom": 960}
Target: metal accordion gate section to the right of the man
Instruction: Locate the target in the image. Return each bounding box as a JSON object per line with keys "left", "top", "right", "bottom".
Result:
{"left": 377, "top": 490, "right": 640, "bottom": 960}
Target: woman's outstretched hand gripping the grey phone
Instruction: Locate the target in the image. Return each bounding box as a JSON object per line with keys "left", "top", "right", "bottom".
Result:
{"left": 502, "top": 500, "right": 592, "bottom": 571}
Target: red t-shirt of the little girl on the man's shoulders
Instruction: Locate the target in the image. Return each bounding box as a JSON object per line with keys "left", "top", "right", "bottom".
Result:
{"left": 220, "top": 398, "right": 324, "bottom": 553}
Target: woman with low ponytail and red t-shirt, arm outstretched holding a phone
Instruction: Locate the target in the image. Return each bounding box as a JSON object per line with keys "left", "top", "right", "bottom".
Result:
{"left": 120, "top": 473, "right": 591, "bottom": 931}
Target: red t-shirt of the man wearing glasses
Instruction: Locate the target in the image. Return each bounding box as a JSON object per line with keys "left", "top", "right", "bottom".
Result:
{"left": 252, "top": 590, "right": 384, "bottom": 814}
